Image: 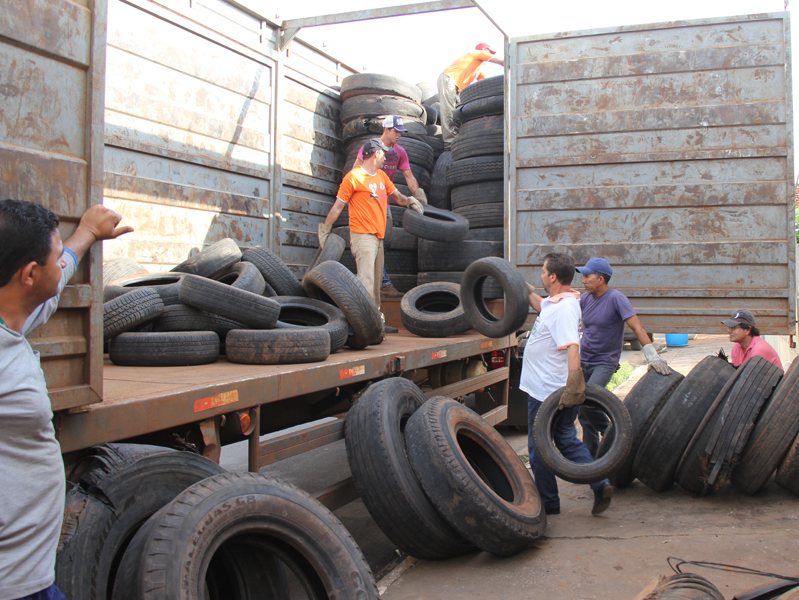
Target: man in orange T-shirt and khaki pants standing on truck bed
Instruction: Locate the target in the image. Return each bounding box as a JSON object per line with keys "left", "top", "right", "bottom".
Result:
{"left": 319, "top": 138, "right": 424, "bottom": 308}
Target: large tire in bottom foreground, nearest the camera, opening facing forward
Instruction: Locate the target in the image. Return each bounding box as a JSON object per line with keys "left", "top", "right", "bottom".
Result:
{"left": 114, "top": 473, "right": 379, "bottom": 600}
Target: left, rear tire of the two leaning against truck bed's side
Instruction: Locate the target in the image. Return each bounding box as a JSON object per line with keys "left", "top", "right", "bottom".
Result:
{"left": 344, "top": 377, "right": 473, "bottom": 560}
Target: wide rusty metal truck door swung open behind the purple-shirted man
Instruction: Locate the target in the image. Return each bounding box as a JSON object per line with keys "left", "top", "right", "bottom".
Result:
{"left": 507, "top": 13, "right": 796, "bottom": 335}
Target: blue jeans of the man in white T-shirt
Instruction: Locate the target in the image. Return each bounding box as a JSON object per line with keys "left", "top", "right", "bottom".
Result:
{"left": 527, "top": 395, "right": 610, "bottom": 510}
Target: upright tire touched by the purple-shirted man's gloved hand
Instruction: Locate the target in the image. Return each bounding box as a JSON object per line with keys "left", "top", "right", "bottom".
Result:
{"left": 597, "top": 369, "right": 684, "bottom": 488}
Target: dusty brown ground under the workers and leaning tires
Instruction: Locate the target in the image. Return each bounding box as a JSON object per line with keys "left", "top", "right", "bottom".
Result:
{"left": 380, "top": 335, "right": 799, "bottom": 600}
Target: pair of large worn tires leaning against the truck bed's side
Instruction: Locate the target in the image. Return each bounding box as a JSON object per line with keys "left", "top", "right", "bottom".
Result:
{"left": 345, "top": 377, "right": 546, "bottom": 560}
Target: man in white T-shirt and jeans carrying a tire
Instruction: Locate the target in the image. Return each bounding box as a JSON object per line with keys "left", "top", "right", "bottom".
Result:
{"left": 519, "top": 252, "right": 613, "bottom": 515}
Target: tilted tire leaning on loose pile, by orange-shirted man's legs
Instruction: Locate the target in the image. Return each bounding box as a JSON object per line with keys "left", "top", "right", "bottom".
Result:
{"left": 303, "top": 261, "right": 383, "bottom": 350}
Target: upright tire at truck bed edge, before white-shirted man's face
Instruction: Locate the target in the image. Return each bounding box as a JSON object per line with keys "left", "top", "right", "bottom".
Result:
{"left": 461, "top": 256, "right": 530, "bottom": 338}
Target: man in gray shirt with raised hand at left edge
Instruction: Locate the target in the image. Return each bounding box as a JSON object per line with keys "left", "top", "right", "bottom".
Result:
{"left": 0, "top": 200, "right": 133, "bottom": 600}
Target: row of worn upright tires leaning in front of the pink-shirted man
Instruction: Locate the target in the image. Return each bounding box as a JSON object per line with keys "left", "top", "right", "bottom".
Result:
{"left": 597, "top": 356, "right": 799, "bottom": 495}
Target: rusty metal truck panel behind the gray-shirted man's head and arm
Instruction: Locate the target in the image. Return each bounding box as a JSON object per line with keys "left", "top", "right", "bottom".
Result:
{"left": 0, "top": 0, "right": 106, "bottom": 410}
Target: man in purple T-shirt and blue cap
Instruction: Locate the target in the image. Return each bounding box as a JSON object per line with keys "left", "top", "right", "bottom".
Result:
{"left": 577, "top": 258, "right": 671, "bottom": 456}
